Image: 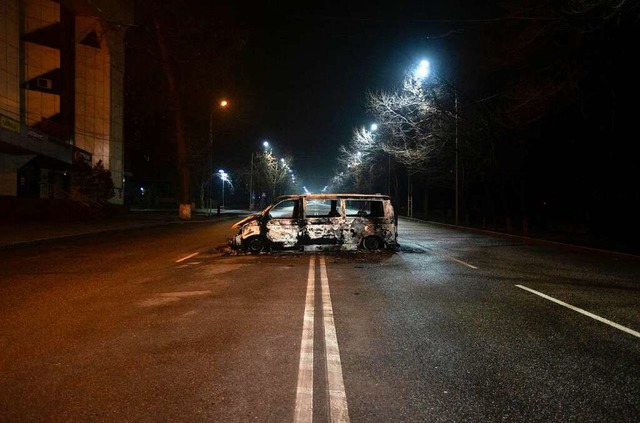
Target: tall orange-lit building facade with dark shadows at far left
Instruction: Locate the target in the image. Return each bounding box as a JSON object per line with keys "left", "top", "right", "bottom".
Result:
{"left": 0, "top": 0, "right": 133, "bottom": 204}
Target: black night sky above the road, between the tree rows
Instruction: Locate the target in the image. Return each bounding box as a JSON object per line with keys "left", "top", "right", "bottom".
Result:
{"left": 226, "top": 2, "right": 480, "bottom": 189}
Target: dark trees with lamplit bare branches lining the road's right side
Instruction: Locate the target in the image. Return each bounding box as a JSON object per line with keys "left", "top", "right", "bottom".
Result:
{"left": 334, "top": 1, "right": 640, "bottom": 252}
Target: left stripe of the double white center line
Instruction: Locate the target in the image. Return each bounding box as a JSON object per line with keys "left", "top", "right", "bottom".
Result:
{"left": 293, "top": 256, "right": 316, "bottom": 423}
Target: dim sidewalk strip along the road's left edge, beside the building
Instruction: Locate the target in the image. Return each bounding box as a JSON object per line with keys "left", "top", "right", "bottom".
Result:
{"left": 0, "top": 209, "right": 251, "bottom": 249}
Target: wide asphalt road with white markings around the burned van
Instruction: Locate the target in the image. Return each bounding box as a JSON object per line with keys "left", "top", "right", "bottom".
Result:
{"left": 0, "top": 220, "right": 640, "bottom": 422}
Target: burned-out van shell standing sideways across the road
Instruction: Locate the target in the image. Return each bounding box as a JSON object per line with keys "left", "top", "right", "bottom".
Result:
{"left": 229, "top": 194, "right": 398, "bottom": 254}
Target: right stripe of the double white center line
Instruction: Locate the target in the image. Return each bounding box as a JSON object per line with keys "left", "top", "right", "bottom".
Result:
{"left": 320, "top": 255, "right": 349, "bottom": 423}
